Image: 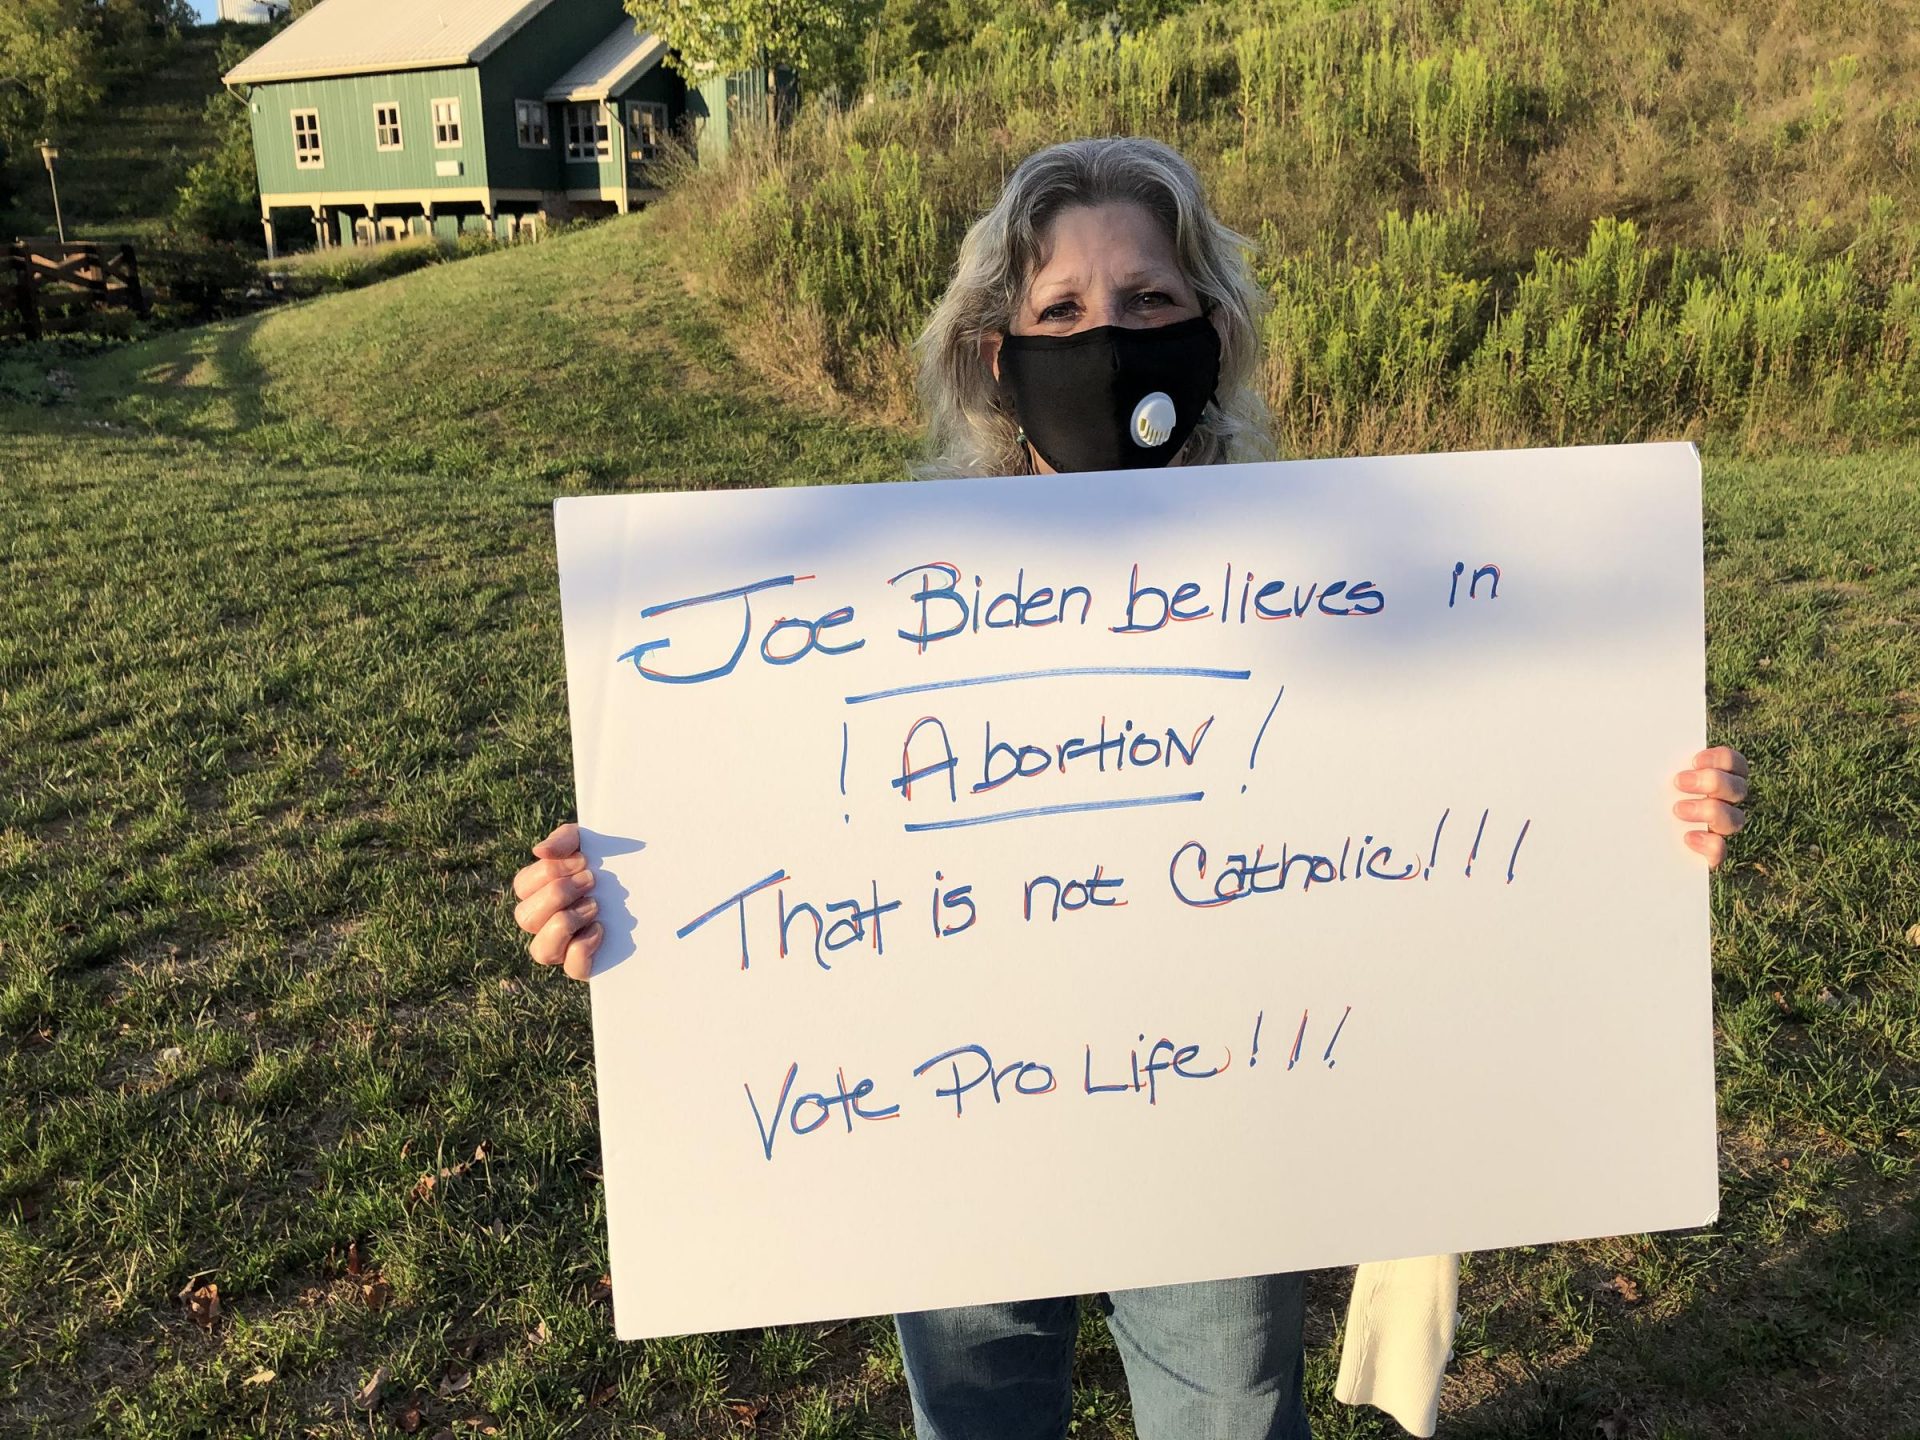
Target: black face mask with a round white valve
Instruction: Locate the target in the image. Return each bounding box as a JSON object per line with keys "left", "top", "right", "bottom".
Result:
{"left": 1000, "top": 315, "right": 1219, "bottom": 470}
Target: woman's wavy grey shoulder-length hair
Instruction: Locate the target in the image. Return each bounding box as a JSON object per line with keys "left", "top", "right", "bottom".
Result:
{"left": 914, "top": 136, "right": 1273, "bottom": 476}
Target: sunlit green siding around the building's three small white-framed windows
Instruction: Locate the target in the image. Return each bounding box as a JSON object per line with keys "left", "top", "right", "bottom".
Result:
{"left": 252, "top": 65, "right": 487, "bottom": 194}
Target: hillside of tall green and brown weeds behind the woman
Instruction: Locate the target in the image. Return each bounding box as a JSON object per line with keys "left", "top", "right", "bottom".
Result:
{"left": 670, "top": 0, "right": 1920, "bottom": 453}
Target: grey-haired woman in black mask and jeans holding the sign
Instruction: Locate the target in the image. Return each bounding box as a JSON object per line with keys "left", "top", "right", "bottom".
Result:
{"left": 515, "top": 138, "right": 1747, "bottom": 1440}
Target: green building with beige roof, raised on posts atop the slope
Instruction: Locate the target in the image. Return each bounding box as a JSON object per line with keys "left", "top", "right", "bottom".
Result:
{"left": 225, "top": 0, "right": 764, "bottom": 255}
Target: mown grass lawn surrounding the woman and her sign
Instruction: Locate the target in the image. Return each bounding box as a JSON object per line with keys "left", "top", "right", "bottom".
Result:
{"left": 0, "top": 217, "right": 1920, "bottom": 1440}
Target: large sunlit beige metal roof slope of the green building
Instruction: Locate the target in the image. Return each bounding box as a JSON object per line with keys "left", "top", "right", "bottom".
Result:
{"left": 221, "top": 0, "right": 553, "bottom": 84}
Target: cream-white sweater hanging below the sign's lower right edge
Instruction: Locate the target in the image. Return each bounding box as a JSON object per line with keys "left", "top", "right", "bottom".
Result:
{"left": 1332, "top": 1256, "right": 1459, "bottom": 1436}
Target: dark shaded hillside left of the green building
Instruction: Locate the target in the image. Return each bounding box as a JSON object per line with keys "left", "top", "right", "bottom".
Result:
{"left": 12, "top": 25, "right": 232, "bottom": 240}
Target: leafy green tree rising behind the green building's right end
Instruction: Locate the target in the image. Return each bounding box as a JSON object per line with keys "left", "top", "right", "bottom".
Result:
{"left": 626, "top": 0, "right": 879, "bottom": 121}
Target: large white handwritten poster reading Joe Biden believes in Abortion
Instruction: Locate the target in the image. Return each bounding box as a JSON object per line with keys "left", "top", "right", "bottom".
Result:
{"left": 555, "top": 444, "right": 1716, "bottom": 1338}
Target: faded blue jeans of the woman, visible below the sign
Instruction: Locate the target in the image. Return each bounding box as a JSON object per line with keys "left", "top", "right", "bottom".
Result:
{"left": 893, "top": 1271, "right": 1313, "bottom": 1440}
